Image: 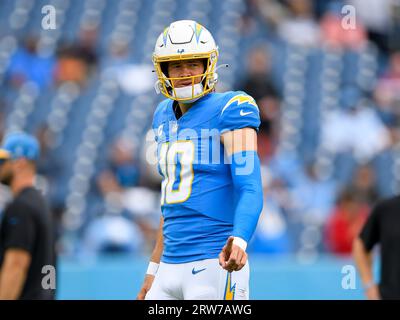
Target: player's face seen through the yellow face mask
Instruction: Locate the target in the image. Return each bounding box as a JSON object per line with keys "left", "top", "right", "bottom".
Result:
{"left": 168, "top": 59, "right": 204, "bottom": 88}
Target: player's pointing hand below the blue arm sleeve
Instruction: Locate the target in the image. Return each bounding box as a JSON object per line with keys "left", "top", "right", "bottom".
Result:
{"left": 219, "top": 237, "right": 247, "bottom": 272}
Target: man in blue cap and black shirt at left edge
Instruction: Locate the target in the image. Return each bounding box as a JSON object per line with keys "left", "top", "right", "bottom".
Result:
{"left": 0, "top": 133, "right": 55, "bottom": 300}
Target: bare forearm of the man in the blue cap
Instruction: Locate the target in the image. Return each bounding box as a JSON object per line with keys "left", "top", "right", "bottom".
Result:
{"left": 0, "top": 249, "right": 31, "bottom": 300}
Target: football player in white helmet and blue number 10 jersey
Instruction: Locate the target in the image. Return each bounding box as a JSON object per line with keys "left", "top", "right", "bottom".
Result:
{"left": 138, "top": 20, "right": 263, "bottom": 300}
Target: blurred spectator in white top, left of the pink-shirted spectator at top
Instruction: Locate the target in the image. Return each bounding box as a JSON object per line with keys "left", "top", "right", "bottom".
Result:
{"left": 278, "top": 0, "right": 320, "bottom": 47}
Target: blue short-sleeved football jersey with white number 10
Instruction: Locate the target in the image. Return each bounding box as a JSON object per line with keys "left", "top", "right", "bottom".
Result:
{"left": 153, "top": 91, "right": 260, "bottom": 263}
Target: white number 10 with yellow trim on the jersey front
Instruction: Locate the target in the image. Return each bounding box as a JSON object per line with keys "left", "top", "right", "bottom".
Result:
{"left": 158, "top": 140, "right": 195, "bottom": 205}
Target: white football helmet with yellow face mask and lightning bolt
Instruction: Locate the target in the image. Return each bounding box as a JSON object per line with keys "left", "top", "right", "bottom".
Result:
{"left": 153, "top": 20, "right": 218, "bottom": 103}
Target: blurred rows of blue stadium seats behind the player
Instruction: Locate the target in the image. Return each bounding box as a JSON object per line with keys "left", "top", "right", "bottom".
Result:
{"left": 0, "top": 0, "right": 400, "bottom": 262}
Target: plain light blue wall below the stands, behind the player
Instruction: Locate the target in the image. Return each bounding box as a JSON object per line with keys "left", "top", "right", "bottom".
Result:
{"left": 57, "top": 256, "right": 378, "bottom": 300}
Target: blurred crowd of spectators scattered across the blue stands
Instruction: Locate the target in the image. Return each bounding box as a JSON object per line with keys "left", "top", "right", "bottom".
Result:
{"left": 0, "top": 0, "right": 400, "bottom": 255}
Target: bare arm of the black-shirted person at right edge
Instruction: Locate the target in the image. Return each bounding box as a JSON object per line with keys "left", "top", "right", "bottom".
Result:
{"left": 353, "top": 238, "right": 380, "bottom": 300}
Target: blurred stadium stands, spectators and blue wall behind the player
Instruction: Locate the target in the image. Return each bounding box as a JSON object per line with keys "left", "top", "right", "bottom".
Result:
{"left": 0, "top": 0, "right": 400, "bottom": 299}
